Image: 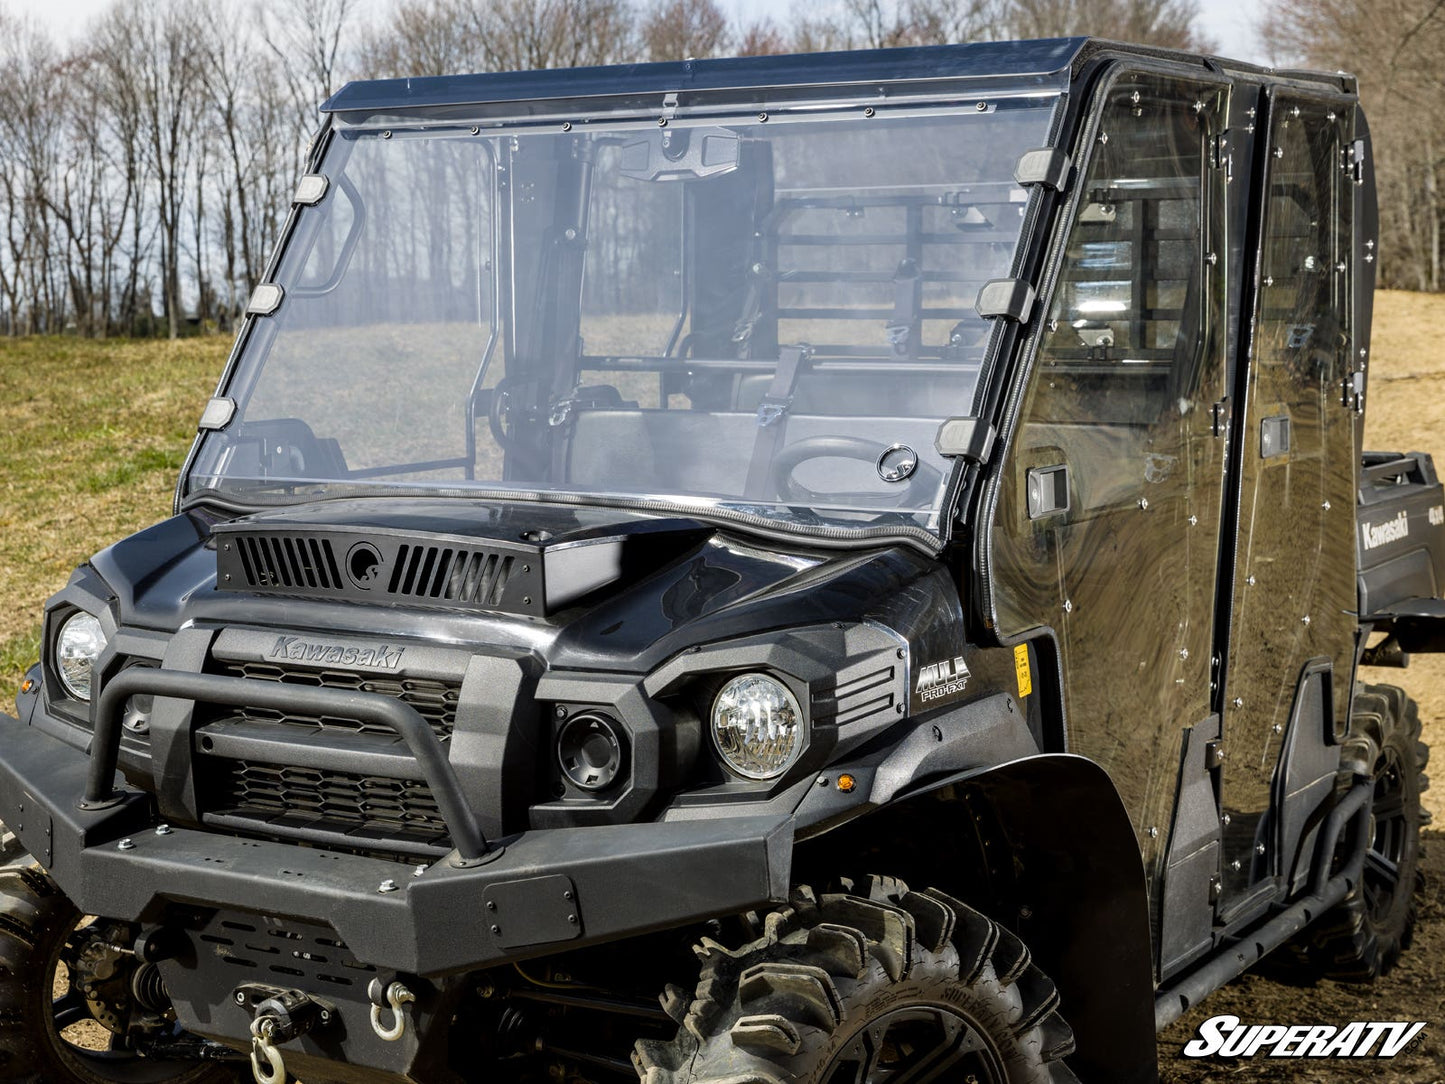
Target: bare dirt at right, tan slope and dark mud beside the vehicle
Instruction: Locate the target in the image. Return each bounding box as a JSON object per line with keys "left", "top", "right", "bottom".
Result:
{"left": 1159, "top": 292, "right": 1445, "bottom": 1084}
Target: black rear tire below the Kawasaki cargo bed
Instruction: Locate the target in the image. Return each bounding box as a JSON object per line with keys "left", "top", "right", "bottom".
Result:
{"left": 1289, "top": 685, "right": 1431, "bottom": 983}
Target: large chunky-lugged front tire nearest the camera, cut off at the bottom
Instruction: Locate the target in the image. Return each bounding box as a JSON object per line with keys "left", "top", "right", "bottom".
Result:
{"left": 633, "top": 877, "right": 1077, "bottom": 1084}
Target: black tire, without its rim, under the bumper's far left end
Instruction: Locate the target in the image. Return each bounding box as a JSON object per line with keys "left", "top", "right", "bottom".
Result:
{"left": 0, "top": 866, "right": 242, "bottom": 1084}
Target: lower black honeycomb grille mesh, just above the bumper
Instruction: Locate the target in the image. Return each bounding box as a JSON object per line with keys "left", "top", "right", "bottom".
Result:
{"left": 204, "top": 757, "right": 451, "bottom": 853}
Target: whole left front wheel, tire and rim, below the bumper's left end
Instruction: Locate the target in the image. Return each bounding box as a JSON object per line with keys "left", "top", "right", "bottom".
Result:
{"left": 0, "top": 867, "right": 242, "bottom": 1084}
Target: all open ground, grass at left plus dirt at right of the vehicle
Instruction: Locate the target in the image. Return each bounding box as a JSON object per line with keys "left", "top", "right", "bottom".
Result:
{"left": 0, "top": 292, "right": 1445, "bottom": 1084}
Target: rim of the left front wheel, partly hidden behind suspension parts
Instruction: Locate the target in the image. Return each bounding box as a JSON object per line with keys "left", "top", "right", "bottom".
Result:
{"left": 45, "top": 919, "right": 202, "bottom": 1084}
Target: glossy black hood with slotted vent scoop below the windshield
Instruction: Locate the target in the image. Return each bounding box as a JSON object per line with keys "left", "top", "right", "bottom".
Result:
{"left": 92, "top": 499, "right": 961, "bottom": 674}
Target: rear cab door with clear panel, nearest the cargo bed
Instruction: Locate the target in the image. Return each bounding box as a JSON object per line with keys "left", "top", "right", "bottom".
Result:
{"left": 1220, "top": 88, "right": 1358, "bottom": 924}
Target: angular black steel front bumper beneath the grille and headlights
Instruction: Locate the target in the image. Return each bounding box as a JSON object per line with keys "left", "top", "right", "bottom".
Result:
{"left": 0, "top": 705, "right": 793, "bottom": 977}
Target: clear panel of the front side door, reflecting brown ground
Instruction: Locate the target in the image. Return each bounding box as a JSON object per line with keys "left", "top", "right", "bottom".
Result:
{"left": 987, "top": 75, "right": 1224, "bottom": 896}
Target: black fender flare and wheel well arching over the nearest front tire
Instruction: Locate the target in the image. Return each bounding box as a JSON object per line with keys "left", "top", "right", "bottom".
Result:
{"left": 795, "top": 753, "right": 1159, "bottom": 1084}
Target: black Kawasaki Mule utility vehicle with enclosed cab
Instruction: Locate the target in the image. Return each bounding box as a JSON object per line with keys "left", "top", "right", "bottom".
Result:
{"left": 0, "top": 39, "right": 1445, "bottom": 1084}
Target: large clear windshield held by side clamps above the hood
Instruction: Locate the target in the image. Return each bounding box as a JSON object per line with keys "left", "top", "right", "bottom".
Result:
{"left": 186, "top": 95, "right": 1058, "bottom": 528}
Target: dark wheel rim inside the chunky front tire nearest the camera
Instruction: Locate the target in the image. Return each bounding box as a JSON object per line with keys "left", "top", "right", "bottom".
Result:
{"left": 822, "top": 1005, "right": 1006, "bottom": 1084}
